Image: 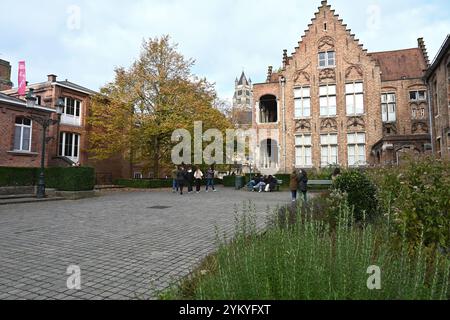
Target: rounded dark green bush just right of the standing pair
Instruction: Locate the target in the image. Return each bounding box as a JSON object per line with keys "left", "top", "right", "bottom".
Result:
{"left": 333, "top": 170, "right": 380, "bottom": 221}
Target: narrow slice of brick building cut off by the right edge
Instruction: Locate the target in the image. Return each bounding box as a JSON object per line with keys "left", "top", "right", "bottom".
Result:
{"left": 425, "top": 35, "right": 450, "bottom": 157}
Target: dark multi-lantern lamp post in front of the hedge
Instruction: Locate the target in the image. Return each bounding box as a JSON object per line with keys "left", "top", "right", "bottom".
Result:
{"left": 25, "top": 89, "right": 64, "bottom": 199}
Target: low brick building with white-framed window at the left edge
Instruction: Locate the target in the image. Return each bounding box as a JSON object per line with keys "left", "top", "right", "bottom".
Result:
{"left": 0, "top": 93, "right": 56, "bottom": 167}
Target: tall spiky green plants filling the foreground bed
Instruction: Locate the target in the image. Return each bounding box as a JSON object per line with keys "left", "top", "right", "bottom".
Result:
{"left": 166, "top": 200, "right": 450, "bottom": 300}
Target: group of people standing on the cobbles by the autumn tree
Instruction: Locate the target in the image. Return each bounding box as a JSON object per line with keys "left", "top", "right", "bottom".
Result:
{"left": 172, "top": 165, "right": 217, "bottom": 195}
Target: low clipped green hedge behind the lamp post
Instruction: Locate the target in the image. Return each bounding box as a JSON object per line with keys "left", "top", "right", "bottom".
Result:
{"left": 0, "top": 167, "right": 95, "bottom": 191}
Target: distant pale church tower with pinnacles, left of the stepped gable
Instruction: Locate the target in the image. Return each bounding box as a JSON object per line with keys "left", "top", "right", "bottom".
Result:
{"left": 232, "top": 71, "right": 253, "bottom": 128}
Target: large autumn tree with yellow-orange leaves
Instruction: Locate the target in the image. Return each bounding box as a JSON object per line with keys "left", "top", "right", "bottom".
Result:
{"left": 89, "top": 36, "right": 234, "bottom": 177}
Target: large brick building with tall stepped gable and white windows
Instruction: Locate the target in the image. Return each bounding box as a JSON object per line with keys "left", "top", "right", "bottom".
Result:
{"left": 253, "top": 1, "right": 430, "bottom": 172}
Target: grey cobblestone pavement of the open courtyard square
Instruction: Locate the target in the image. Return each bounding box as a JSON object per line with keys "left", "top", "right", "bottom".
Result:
{"left": 0, "top": 189, "right": 289, "bottom": 300}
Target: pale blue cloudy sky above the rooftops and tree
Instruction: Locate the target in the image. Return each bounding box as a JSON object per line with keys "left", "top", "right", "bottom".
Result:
{"left": 0, "top": 0, "right": 450, "bottom": 99}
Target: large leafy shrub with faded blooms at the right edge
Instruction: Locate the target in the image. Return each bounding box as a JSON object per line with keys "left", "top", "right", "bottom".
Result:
{"left": 370, "top": 157, "right": 450, "bottom": 251}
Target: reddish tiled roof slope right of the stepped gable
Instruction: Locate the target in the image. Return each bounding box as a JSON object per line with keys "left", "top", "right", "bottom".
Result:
{"left": 369, "top": 48, "right": 427, "bottom": 81}
